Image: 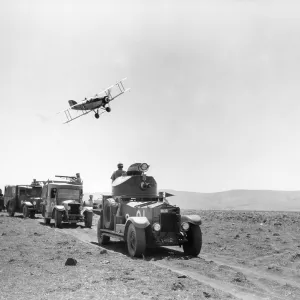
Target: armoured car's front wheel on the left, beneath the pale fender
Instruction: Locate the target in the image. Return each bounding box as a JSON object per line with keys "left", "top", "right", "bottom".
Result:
{"left": 126, "top": 224, "right": 146, "bottom": 257}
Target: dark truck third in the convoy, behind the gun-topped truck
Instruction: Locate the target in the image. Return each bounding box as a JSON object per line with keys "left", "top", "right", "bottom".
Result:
{"left": 4, "top": 179, "right": 42, "bottom": 218}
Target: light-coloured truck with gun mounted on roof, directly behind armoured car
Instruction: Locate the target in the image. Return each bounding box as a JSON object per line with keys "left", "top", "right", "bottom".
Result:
{"left": 42, "top": 176, "right": 93, "bottom": 228}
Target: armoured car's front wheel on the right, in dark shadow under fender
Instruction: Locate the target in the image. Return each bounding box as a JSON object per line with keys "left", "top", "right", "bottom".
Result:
{"left": 183, "top": 224, "right": 202, "bottom": 256}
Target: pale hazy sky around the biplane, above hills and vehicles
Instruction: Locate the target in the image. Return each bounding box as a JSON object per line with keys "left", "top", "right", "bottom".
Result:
{"left": 0, "top": 0, "right": 300, "bottom": 192}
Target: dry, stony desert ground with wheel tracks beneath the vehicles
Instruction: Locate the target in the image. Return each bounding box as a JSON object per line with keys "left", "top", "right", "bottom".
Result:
{"left": 0, "top": 210, "right": 300, "bottom": 299}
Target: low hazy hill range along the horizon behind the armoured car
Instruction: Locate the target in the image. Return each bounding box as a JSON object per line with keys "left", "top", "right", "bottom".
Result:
{"left": 84, "top": 189, "right": 300, "bottom": 211}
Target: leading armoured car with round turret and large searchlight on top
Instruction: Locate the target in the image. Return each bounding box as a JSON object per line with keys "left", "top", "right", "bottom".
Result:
{"left": 95, "top": 163, "right": 202, "bottom": 257}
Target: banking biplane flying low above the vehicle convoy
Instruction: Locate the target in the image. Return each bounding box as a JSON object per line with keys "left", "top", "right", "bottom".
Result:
{"left": 63, "top": 78, "right": 130, "bottom": 124}
